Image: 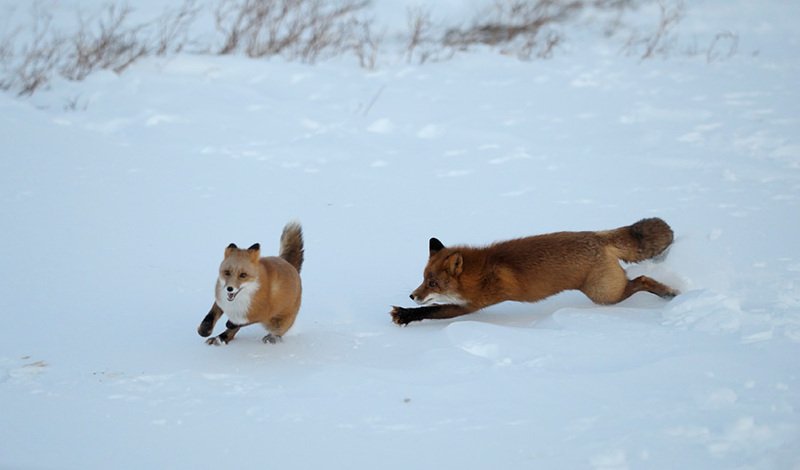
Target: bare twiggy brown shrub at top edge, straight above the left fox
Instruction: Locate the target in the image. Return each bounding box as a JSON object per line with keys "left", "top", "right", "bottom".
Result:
{"left": 215, "top": 0, "right": 368, "bottom": 63}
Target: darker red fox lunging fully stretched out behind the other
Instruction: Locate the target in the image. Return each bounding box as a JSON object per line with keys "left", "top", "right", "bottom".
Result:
{"left": 391, "top": 218, "right": 678, "bottom": 325}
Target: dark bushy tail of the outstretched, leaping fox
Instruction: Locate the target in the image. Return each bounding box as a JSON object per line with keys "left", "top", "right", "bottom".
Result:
{"left": 610, "top": 217, "right": 674, "bottom": 263}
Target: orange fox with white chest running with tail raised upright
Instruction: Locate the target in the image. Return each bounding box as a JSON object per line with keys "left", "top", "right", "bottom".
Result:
{"left": 197, "top": 222, "right": 303, "bottom": 345}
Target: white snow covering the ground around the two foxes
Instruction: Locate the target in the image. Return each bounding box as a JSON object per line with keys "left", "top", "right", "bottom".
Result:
{"left": 0, "top": 0, "right": 800, "bottom": 470}
